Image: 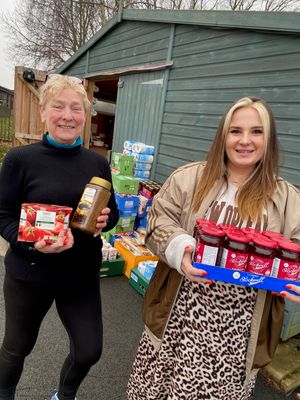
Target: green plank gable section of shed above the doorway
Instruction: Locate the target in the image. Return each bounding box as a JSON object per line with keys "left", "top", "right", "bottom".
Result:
{"left": 64, "top": 21, "right": 170, "bottom": 76}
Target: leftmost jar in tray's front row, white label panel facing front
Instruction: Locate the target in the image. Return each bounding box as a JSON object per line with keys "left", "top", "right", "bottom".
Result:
{"left": 194, "top": 225, "right": 224, "bottom": 266}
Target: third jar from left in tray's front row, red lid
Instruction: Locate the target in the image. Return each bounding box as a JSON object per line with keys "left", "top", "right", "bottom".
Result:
{"left": 247, "top": 234, "right": 277, "bottom": 276}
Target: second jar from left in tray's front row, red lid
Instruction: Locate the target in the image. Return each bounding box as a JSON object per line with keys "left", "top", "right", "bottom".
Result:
{"left": 220, "top": 231, "right": 250, "bottom": 271}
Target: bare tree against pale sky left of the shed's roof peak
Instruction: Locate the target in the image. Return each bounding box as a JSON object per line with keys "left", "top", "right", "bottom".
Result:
{"left": 1, "top": 0, "right": 101, "bottom": 69}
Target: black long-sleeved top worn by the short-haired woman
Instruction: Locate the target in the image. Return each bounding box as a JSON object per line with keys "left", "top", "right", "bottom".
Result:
{"left": 0, "top": 134, "right": 119, "bottom": 284}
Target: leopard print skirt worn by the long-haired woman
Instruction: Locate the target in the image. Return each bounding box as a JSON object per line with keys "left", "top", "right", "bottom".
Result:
{"left": 127, "top": 279, "right": 257, "bottom": 400}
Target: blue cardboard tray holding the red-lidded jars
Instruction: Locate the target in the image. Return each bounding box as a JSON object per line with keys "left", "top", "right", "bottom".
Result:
{"left": 194, "top": 263, "right": 300, "bottom": 294}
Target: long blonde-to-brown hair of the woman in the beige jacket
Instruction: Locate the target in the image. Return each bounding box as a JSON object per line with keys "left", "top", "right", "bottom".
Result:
{"left": 193, "top": 97, "right": 279, "bottom": 221}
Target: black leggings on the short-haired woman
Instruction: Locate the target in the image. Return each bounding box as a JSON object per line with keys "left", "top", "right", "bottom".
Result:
{"left": 0, "top": 273, "right": 102, "bottom": 400}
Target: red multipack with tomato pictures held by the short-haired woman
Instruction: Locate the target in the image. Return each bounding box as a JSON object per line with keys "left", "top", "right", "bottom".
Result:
{"left": 18, "top": 203, "right": 72, "bottom": 243}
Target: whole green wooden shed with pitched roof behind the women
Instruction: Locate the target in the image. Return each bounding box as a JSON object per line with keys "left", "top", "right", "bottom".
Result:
{"left": 58, "top": 9, "right": 300, "bottom": 186}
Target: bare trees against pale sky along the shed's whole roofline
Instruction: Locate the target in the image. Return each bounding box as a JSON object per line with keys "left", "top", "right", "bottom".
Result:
{"left": 0, "top": 0, "right": 300, "bottom": 70}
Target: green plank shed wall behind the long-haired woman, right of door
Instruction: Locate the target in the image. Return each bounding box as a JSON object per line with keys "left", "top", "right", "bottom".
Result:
{"left": 155, "top": 25, "right": 300, "bottom": 186}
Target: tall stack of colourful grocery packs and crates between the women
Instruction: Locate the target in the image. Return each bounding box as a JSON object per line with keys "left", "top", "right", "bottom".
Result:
{"left": 103, "top": 141, "right": 160, "bottom": 295}
